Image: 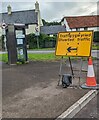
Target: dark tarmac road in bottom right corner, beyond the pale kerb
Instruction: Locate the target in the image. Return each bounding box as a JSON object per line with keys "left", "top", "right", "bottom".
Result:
{"left": 74, "top": 61, "right": 99, "bottom": 119}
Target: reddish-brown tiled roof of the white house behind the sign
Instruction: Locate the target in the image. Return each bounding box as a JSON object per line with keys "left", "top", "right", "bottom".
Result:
{"left": 62, "top": 15, "right": 99, "bottom": 28}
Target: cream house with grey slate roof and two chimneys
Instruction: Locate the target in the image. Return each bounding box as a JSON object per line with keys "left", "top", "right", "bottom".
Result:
{"left": 0, "top": 1, "right": 43, "bottom": 34}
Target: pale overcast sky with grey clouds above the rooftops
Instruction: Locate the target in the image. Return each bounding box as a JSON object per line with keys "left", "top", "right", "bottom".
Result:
{"left": 0, "top": 0, "right": 98, "bottom": 21}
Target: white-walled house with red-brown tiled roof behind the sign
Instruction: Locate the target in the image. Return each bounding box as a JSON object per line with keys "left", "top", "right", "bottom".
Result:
{"left": 61, "top": 15, "right": 99, "bottom": 31}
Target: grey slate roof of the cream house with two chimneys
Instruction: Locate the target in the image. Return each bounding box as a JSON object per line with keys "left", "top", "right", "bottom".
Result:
{"left": 0, "top": 10, "right": 37, "bottom": 24}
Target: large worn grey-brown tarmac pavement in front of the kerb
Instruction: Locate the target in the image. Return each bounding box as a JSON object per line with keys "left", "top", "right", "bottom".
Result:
{"left": 2, "top": 60, "right": 97, "bottom": 118}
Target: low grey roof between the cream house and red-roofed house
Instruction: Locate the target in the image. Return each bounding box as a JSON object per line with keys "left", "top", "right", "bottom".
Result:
{"left": 40, "top": 25, "right": 66, "bottom": 35}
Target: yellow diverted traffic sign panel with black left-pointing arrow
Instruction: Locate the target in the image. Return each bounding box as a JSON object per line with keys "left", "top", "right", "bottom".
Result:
{"left": 56, "top": 31, "right": 93, "bottom": 57}
